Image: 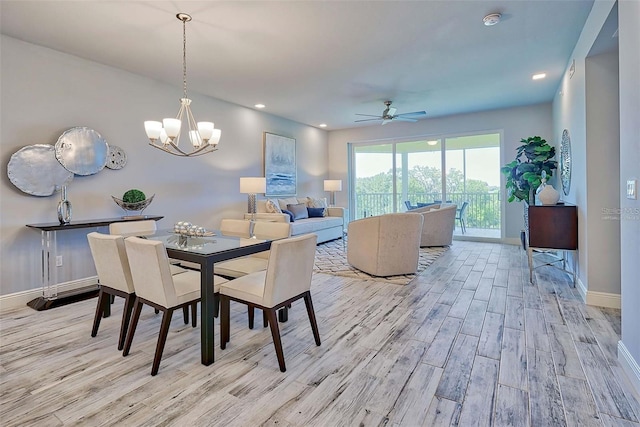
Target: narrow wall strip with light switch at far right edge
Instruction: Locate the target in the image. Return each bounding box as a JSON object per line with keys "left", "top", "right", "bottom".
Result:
{"left": 618, "top": 1, "right": 640, "bottom": 393}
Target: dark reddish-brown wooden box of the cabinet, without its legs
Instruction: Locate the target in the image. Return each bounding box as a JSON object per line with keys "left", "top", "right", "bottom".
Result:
{"left": 529, "top": 204, "right": 578, "bottom": 250}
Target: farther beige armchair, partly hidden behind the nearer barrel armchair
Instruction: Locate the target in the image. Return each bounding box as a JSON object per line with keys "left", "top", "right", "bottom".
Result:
{"left": 405, "top": 203, "right": 457, "bottom": 247}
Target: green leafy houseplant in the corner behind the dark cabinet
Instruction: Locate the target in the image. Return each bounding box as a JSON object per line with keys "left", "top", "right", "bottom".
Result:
{"left": 500, "top": 136, "right": 558, "bottom": 204}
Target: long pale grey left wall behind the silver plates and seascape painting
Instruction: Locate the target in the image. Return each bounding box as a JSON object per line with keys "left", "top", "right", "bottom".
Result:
{"left": 0, "top": 35, "right": 327, "bottom": 295}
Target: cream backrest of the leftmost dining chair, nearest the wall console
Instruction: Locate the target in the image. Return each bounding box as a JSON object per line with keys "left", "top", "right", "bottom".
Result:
{"left": 87, "top": 232, "right": 134, "bottom": 294}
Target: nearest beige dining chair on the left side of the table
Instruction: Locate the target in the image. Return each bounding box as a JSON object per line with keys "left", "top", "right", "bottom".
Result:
{"left": 123, "top": 237, "right": 227, "bottom": 375}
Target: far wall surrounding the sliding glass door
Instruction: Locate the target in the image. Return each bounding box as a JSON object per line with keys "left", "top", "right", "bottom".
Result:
{"left": 329, "top": 104, "right": 555, "bottom": 242}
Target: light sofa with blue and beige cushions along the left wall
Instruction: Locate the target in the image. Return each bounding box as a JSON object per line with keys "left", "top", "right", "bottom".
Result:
{"left": 244, "top": 197, "right": 346, "bottom": 243}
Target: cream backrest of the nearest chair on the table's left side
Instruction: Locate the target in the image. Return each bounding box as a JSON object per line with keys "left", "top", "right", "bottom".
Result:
{"left": 124, "top": 237, "right": 178, "bottom": 308}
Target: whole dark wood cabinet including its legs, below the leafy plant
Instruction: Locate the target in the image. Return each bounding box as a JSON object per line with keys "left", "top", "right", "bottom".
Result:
{"left": 527, "top": 204, "right": 578, "bottom": 286}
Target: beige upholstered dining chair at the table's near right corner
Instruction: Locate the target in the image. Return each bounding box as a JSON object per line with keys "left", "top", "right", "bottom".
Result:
{"left": 220, "top": 234, "right": 320, "bottom": 372}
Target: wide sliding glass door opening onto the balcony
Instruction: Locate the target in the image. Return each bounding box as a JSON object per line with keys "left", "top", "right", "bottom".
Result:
{"left": 350, "top": 133, "right": 501, "bottom": 238}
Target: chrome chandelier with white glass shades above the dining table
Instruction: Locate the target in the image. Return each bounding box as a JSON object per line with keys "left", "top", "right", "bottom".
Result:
{"left": 144, "top": 13, "right": 222, "bottom": 157}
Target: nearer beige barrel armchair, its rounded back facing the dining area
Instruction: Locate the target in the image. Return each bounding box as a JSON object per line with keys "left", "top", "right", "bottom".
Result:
{"left": 347, "top": 213, "right": 423, "bottom": 276}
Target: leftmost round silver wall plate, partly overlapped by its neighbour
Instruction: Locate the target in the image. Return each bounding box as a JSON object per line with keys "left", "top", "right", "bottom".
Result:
{"left": 7, "top": 144, "right": 73, "bottom": 196}
